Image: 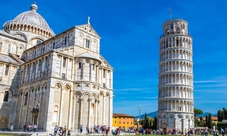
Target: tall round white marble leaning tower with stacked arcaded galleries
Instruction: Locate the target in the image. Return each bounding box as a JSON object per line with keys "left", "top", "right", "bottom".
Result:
{"left": 157, "top": 19, "right": 194, "bottom": 133}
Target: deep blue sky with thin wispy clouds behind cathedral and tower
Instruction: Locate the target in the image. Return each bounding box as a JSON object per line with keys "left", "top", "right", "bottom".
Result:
{"left": 0, "top": 0, "right": 227, "bottom": 116}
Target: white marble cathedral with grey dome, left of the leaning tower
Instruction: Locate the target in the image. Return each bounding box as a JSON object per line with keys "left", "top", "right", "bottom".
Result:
{"left": 0, "top": 2, "right": 113, "bottom": 131}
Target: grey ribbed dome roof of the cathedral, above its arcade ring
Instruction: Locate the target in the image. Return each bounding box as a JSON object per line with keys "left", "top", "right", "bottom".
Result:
{"left": 4, "top": 2, "right": 54, "bottom": 35}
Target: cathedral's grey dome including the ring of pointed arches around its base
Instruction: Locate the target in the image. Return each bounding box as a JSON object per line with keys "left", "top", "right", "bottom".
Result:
{"left": 3, "top": 2, "right": 54, "bottom": 37}
